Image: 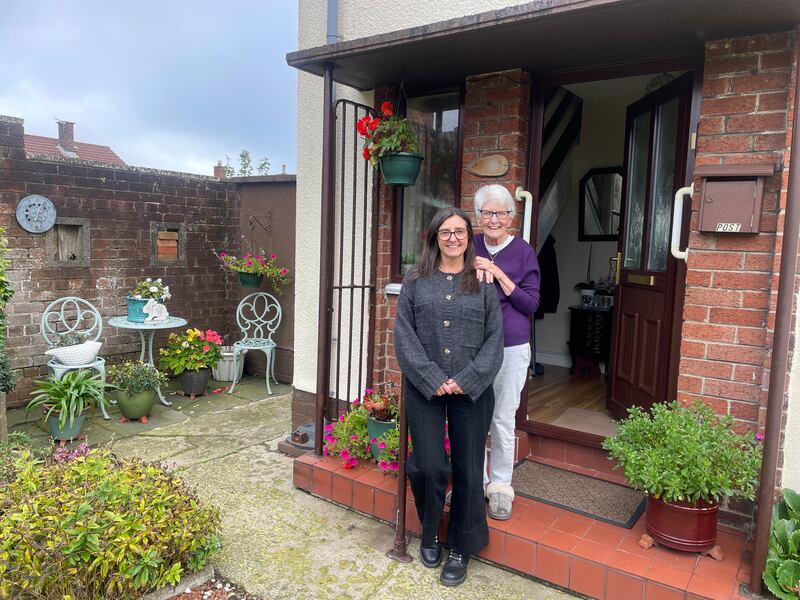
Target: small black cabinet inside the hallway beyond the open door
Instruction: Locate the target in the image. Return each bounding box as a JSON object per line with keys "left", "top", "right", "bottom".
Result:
{"left": 568, "top": 305, "right": 614, "bottom": 377}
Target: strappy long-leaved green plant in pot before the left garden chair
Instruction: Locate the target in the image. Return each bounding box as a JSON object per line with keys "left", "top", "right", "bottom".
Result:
{"left": 25, "top": 370, "right": 109, "bottom": 441}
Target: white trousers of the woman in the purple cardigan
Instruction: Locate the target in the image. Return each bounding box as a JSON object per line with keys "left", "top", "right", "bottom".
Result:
{"left": 483, "top": 344, "right": 531, "bottom": 485}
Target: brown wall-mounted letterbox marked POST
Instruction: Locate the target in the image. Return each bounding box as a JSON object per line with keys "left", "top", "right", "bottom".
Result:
{"left": 694, "top": 163, "right": 775, "bottom": 233}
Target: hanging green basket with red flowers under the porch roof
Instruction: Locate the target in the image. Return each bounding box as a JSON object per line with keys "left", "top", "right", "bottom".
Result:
{"left": 356, "top": 102, "right": 423, "bottom": 185}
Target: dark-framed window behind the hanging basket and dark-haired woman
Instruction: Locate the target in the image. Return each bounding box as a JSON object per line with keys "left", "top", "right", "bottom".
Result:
{"left": 393, "top": 92, "right": 461, "bottom": 281}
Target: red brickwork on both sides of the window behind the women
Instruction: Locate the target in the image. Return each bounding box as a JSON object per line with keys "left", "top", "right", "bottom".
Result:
{"left": 373, "top": 69, "right": 530, "bottom": 389}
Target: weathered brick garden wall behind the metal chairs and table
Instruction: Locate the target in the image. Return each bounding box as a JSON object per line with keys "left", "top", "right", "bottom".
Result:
{"left": 0, "top": 117, "right": 239, "bottom": 406}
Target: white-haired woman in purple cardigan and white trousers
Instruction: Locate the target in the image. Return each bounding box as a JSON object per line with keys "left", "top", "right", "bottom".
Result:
{"left": 475, "top": 185, "right": 539, "bottom": 521}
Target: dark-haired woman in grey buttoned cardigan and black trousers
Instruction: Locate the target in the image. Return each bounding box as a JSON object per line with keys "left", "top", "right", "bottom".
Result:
{"left": 394, "top": 208, "right": 503, "bottom": 586}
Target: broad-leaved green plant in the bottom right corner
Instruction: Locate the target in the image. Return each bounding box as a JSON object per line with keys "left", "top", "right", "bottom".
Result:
{"left": 763, "top": 489, "right": 800, "bottom": 600}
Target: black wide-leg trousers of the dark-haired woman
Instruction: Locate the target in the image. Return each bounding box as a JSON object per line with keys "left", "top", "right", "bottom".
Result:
{"left": 405, "top": 379, "right": 494, "bottom": 555}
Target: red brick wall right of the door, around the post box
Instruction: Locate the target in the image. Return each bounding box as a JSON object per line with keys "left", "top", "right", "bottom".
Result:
{"left": 678, "top": 32, "right": 797, "bottom": 502}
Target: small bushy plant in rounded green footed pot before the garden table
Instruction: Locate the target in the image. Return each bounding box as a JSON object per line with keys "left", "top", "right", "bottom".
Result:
{"left": 108, "top": 361, "right": 167, "bottom": 423}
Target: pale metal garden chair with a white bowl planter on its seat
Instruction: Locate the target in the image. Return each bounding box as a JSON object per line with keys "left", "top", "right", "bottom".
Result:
{"left": 40, "top": 296, "right": 111, "bottom": 419}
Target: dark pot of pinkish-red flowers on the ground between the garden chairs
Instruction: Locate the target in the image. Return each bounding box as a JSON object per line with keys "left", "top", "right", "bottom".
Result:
{"left": 158, "top": 329, "right": 222, "bottom": 400}
